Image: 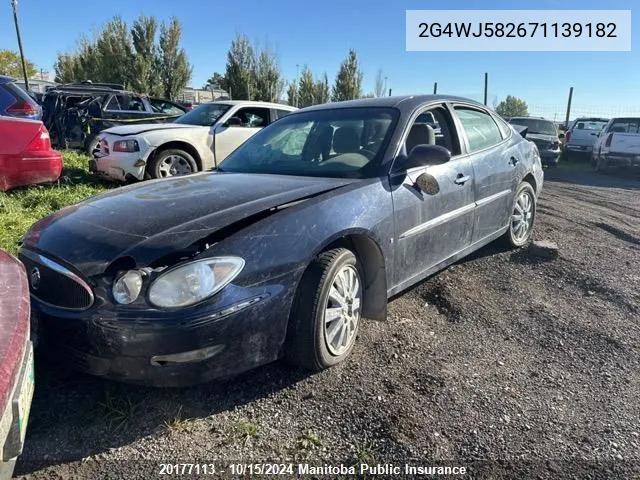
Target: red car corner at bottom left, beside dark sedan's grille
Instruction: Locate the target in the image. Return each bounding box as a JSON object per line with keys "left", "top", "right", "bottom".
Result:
{"left": 0, "top": 249, "right": 35, "bottom": 480}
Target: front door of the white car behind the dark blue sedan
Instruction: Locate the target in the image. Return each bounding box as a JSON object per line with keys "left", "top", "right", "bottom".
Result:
{"left": 213, "top": 107, "right": 270, "bottom": 163}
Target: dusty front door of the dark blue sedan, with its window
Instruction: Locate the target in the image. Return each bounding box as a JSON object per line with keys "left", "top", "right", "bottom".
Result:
{"left": 391, "top": 105, "right": 475, "bottom": 291}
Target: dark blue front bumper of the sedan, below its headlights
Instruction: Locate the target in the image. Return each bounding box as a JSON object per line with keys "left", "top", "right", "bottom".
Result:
{"left": 32, "top": 283, "right": 292, "bottom": 387}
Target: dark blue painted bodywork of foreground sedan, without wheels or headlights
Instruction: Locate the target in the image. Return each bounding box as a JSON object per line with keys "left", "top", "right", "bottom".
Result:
{"left": 21, "top": 96, "right": 543, "bottom": 385}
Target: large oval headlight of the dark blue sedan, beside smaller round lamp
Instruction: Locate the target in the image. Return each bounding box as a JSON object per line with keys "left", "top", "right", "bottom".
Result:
{"left": 149, "top": 257, "right": 244, "bottom": 308}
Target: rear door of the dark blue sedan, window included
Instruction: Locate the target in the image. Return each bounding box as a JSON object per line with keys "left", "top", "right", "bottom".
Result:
{"left": 453, "top": 104, "right": 522, "bottom": 243}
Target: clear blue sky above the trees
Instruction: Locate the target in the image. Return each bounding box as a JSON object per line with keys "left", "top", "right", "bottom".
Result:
{"left": 0, "top": 0, "right": 640, "bottom": 121}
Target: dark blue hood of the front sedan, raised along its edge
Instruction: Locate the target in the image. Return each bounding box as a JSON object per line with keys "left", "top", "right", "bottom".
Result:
{"left": 24, "top": 172, "right": 356, "bottom": 276}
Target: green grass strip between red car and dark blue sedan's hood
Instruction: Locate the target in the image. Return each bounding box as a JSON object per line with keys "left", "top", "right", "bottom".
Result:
{"left": 0, "top": 151, "right": 119, "bottom": 254}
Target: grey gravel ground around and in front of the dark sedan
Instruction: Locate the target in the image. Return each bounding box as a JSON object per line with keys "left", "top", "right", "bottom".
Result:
{"left": 16, "top": 170, "right": 640, "bottom": 480}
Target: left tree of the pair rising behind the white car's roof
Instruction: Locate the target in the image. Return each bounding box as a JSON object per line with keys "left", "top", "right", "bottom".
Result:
{"left": 224, "top": 34, "right": 256, "bottom": 100}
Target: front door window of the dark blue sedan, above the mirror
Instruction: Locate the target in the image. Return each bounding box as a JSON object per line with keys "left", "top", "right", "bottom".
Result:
{"left": 405, "top": 106, "right": 460, "bottom": 156}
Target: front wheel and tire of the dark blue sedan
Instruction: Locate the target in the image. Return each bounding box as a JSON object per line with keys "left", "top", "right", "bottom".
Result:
{"left": 285, "top": 248, "right": 363, "bottom": 371}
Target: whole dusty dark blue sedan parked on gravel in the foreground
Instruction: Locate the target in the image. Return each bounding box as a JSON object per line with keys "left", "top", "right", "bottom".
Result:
{"left": 20, "top": 96, "right": 543, "bottom": 386}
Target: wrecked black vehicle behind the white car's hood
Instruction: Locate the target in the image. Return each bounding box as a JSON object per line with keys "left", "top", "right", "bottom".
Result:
{"left": 42, "top": 82, "right": 188, "bottom": 154}
